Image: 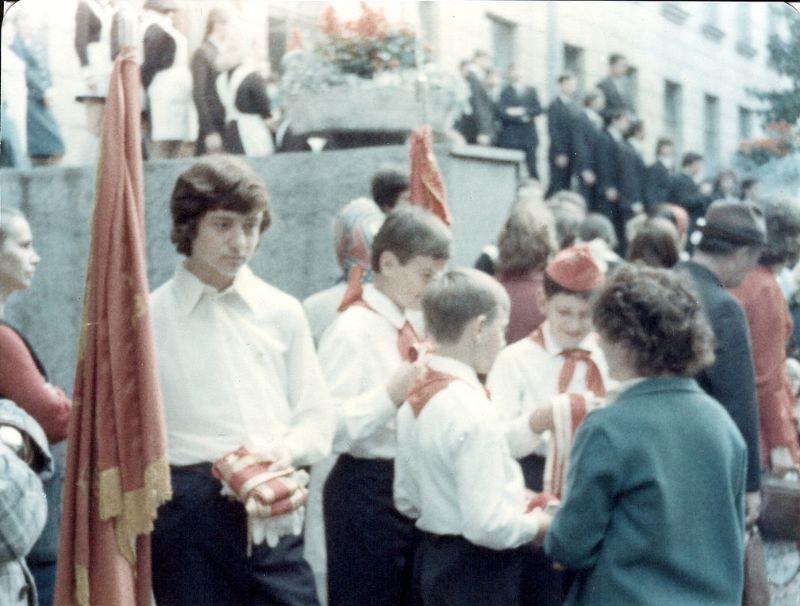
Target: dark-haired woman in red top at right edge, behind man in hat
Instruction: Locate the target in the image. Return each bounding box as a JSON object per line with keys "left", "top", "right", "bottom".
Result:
{"left": 732, "top": 200, "right": 800, "bottom": 471}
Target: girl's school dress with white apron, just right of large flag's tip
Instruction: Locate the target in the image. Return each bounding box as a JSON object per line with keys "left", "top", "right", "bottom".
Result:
{"left": 141, "top": 11, "right": 198, "bottom": 141}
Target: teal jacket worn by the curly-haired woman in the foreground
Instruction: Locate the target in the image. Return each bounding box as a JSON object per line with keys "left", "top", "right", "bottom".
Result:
{"left": 545, "top": 378, "right": 747, "bottom": 606}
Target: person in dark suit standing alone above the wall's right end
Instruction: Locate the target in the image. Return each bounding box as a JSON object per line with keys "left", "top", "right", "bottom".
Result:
{"left": 497, "top": 64, "right": 542, "bottom": 179}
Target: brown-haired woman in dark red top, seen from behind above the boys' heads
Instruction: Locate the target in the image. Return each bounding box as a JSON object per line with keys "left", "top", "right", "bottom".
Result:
{"left": 495, "top": 200, "right": 556, "bottom": 344}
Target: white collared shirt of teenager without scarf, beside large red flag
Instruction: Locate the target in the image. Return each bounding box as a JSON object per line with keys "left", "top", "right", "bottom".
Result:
{"left": 150, "top": 263, "right": 333, "bottom": 465}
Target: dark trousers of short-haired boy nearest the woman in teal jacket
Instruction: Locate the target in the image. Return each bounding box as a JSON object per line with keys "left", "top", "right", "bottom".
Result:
{"left": 414, "top": 533, "right": 522, "bottom": 606}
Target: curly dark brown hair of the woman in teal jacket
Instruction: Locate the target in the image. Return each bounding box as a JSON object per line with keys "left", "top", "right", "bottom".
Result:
{"left": 593, "top": 264, "right": 714, "bottom": 377}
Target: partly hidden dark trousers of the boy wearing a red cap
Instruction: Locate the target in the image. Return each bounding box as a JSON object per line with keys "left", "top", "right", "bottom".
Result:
{"left": 519, "top": 454, "right": 570, "bottom": 606}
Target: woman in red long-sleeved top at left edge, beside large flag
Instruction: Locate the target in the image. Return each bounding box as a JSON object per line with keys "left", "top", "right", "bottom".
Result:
{"left": 0, "top": 208, "right": 71, "bottom": 443}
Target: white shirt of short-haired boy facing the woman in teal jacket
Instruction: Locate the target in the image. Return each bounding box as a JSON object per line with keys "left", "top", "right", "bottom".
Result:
{"left": 394, "top": 355, "right": 539, "bottom": 549}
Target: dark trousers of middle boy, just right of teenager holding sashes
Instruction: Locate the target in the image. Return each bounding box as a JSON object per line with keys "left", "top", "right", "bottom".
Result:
{"left": 323, "top": 455, "right": 416, "bottom": 606}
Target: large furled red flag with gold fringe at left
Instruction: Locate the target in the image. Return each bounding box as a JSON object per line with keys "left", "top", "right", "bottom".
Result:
{"left": 56, "top": 49, "right": 171, "bottom": 606}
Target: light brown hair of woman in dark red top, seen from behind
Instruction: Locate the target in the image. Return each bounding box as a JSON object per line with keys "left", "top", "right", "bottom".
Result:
{"left": 497, "top": 200, "right": 556, "bottom": 273}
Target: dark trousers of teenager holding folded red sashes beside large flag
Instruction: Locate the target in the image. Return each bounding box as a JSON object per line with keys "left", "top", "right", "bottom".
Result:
{"left": 152, "top": 465, "right": 319, "bottom": 606}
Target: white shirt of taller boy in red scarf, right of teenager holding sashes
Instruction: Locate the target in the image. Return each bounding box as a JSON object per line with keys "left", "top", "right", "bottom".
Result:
{"left": 319, "top": 284, "right": 416, "bottom": 459}
